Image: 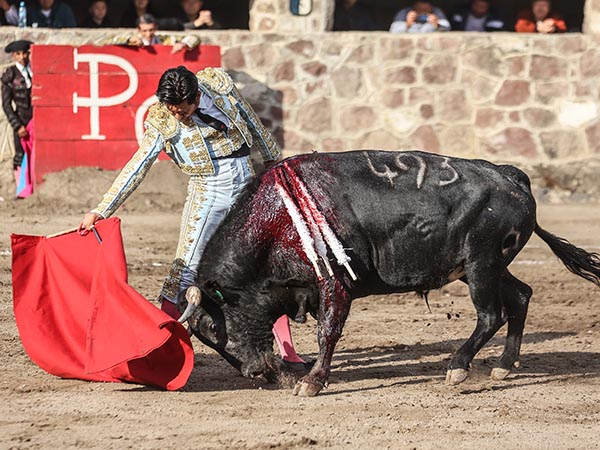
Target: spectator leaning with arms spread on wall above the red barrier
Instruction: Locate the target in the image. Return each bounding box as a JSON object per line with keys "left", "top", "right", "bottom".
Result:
{"left": 101, "top": 14, "right": 200, "bottom": 53}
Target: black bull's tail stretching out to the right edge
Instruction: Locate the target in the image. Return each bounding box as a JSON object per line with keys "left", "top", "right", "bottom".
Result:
{"left": 535, "top": 223, "right": 600, "bottom": 286}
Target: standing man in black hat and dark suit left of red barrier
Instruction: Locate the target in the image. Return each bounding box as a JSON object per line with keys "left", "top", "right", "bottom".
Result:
{"left": 2, "top": 41, "right": 33, "bottom": 181}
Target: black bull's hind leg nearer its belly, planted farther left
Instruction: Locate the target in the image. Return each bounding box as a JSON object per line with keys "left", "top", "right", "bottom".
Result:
{"left": 446, "top": 265, "right": 506, "bottom": 385}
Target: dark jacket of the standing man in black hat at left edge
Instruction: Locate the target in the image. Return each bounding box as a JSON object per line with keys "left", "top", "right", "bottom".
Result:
{"left": 2, "top": 65, "right": 33, "bottom": 131}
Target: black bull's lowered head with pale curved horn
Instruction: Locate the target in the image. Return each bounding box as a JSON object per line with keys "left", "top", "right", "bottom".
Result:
{"left": 179, "top": 286, "right": 282, "bottom": 381}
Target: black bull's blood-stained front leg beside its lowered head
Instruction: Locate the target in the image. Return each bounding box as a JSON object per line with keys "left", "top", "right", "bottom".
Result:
{"left": 294, "top": 278, "right": 350, "bottom": 397}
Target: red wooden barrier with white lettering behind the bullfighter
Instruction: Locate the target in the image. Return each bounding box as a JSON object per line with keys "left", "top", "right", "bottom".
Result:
{"left": 31, "top": 45, "right": 221, "bottom": 182}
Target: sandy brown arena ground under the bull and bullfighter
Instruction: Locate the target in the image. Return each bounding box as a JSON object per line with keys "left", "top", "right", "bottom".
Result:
{"left": 0, "top": 163, "right": 600, "bottom": 450}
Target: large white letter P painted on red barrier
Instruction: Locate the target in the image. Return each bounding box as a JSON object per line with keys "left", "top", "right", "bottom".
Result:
{"left": 73, "top": 49, "right": 138, "bottom": 141}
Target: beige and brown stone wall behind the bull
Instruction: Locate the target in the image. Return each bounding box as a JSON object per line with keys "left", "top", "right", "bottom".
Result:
{"left": 0, "top": 27, "right": 600, "bottom": 198}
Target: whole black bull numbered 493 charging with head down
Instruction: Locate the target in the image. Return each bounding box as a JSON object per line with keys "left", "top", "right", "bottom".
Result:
{"left": 180, "top": 151, "right": 600, "bottom": 396}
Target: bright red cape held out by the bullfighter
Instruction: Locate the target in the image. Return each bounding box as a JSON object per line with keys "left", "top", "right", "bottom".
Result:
{"left": 11, "top": 218, "right": 194, "bottom": 390}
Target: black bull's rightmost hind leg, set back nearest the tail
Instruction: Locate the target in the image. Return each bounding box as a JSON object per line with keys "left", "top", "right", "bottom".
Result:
{"left": 490, "top": 270, "right": 532, "bottom": 380}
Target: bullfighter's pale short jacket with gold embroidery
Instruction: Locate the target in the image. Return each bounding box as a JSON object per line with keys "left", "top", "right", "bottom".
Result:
{"left": 92, "top": 67, "right": 280, "bottom": 217}
